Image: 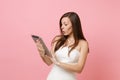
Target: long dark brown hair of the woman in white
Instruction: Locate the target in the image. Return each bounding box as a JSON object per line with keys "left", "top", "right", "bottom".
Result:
{"left": 55, "top": 12, "right": 86, "bottom": 53}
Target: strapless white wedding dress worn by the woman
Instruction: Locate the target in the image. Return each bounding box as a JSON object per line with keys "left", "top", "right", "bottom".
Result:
{"left": 47, "top": 47, "right": 79, "bottom": 80}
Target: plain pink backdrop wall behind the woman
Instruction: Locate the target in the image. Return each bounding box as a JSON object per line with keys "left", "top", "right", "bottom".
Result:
{"left": 0, "top": 0, "right": 120, "bottom": 80}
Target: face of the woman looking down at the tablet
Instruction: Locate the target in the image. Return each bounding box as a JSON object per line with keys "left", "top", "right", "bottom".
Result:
{"left": 61, "top": 17, "right": 72, "bottom": 35}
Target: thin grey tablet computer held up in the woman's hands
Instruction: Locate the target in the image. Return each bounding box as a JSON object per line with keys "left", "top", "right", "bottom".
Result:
{"left": 31, "top": 35, "right": 52, "bottom": 57}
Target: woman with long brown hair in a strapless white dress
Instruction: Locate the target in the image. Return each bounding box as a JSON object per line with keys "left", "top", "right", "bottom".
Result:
{"left": 36, "top": 12, "right": 89, "bottom": 80}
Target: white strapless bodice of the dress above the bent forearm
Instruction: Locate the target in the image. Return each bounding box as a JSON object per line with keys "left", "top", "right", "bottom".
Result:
{"left": 55, "top": 47, "right": 80, "bottom": 63}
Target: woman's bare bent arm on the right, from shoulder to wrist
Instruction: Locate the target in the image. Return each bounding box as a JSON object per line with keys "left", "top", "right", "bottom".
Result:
{"left": 53, "top": 41, "right": 88, "bottom": 73}
